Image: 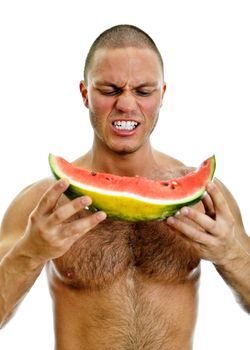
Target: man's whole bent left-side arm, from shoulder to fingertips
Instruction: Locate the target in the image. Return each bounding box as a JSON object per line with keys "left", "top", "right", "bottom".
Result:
{"left": 0, "top": 180, "right": 105, "bottom": 327}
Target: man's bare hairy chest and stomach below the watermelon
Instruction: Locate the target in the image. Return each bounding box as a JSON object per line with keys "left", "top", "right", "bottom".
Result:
{"left": 47, "top": 157, "right": 202, "bottom": 350}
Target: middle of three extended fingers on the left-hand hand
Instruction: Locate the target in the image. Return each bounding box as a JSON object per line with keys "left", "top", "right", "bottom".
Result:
{"left": 47, "top": 196, "right": 91, "bottom": 226}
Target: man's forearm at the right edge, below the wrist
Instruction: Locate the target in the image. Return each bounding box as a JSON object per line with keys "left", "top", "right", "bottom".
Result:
{"left": 215, "top": 239, "right": 250, "bottom": 313}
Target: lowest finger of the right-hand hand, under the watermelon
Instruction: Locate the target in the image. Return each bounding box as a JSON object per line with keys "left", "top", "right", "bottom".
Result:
{"left": 167, "top": 216, "right": 211, "bottom": 245}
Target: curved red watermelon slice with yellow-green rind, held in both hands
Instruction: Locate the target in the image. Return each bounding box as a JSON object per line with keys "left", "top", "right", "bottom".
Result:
{"left": 49, "top": 154, "right": 216, "bottom": 221}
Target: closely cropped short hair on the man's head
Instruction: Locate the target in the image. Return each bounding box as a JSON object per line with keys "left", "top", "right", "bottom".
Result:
{"left": 84, "top": 24, "right": 164, "bottom": 82}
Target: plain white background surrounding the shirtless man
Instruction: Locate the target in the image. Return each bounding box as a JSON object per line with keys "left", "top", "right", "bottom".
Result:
{"left": 0, "top": 0, "right": 250, "bottom": 350}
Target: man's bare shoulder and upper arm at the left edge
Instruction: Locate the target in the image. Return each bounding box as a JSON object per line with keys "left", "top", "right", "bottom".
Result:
{"left": 0, "top": 178, "right": 55, "bottom": 240}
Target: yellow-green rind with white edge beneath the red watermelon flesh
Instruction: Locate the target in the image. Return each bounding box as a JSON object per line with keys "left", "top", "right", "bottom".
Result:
{"left": 49, "top": 154, "right": 216, "bottom": 221}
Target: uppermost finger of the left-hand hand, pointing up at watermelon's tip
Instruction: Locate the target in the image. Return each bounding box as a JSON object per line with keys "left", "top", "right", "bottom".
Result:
{"left": 36, "top": 179, "right": 69, "bottom": 215}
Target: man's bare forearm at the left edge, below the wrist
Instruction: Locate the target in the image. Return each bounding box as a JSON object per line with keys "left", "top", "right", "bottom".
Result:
{"left": 0, "top": 239, "right": 44, "bottom": 328}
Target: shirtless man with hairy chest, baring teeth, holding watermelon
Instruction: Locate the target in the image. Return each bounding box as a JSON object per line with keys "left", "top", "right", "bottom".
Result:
{"left": 0, "top": 25, "right": 250, "bottom": 350}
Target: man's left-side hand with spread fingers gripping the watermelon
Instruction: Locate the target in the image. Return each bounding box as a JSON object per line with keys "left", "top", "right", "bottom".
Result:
{"left": 23, "top": 180, "right": 106, "bottom": 263}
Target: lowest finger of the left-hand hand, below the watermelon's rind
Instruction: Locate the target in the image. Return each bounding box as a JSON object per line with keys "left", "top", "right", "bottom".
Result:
{"left": 62, "top": 211, "right": 107, "bottom": 238}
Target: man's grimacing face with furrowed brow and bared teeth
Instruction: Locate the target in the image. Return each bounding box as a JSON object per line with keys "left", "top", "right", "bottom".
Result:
{"left": 80, "top": 47, "right": 166, "bottom": 153}
